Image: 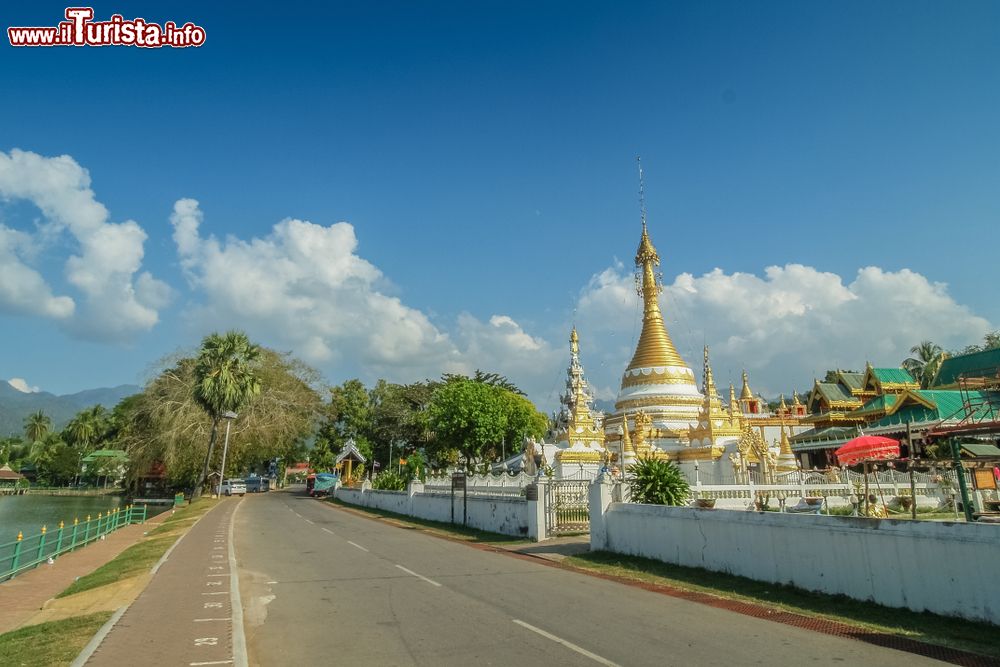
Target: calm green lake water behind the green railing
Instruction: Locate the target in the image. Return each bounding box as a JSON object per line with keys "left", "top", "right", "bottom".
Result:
{"left": 0, "top": 495, "right": 128, "bottom": 544}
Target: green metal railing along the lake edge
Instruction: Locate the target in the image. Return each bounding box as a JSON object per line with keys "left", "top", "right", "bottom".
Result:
{"left": 0, "top": 505, "right": 146, "bottom": 581}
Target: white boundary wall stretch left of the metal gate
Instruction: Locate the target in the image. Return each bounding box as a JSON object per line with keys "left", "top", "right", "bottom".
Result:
{"left": 334, "top": 484, "right": 529, "bottom": 537}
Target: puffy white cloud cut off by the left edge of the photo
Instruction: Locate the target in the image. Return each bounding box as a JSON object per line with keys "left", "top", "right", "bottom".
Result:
{"left": 0, "top": 149, "right": 171, "bottom": 340}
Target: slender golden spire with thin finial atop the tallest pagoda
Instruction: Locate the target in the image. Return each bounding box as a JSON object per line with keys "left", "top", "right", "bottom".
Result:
{"left": 626, "top": 162, "right": 687, "bottom": 373}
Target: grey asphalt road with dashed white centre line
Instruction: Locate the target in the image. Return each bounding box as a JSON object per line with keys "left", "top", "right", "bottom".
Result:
{"left": 235, "top": 492, "right": 942, "bottom": 667}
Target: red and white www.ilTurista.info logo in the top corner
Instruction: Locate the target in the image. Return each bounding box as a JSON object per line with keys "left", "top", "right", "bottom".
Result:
{"left": 7, "top": 7, "right": 205, "bottom": 49}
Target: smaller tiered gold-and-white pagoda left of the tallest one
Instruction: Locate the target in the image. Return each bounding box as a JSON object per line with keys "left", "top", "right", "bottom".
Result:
{"left": 555, "top": 327, "right": 604, "bottom": 464}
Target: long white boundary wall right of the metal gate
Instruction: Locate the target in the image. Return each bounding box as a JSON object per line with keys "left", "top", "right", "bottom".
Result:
{"left": 590, "top": 482, "right": 1000, "bottom": 625}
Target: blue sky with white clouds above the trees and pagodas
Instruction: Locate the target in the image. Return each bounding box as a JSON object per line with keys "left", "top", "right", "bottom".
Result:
{"left": 0, "top": 0, "right": 1000, "bottom": 410}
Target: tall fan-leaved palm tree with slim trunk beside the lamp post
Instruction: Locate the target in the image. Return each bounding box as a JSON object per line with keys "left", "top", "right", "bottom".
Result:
{"left": 191, "top": 331, "right": 260, "bottom": 498}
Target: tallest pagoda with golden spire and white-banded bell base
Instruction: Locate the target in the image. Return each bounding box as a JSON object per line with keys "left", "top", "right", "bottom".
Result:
{"left": 605, "top": 187, "right": 703, "bottom": 455}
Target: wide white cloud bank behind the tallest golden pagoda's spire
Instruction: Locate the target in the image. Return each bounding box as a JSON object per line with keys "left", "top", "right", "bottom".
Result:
{"left": 577, "top": 264, "right": 991, "bottom": 395}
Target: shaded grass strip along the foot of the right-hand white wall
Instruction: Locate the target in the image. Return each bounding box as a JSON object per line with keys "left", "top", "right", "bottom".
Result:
{"left": 563, "top": 551, "right": 1000, "bottom": 658}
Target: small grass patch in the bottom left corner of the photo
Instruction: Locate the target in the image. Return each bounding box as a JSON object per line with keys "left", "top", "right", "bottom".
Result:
{"left": 0, "top": 611, "right": 111, "bottom": 667}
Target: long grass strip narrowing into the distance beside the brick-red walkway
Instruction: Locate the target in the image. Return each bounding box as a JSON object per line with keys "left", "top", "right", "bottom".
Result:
{"left": 57, "top": 498, "right": 218, "bottom": 600}
